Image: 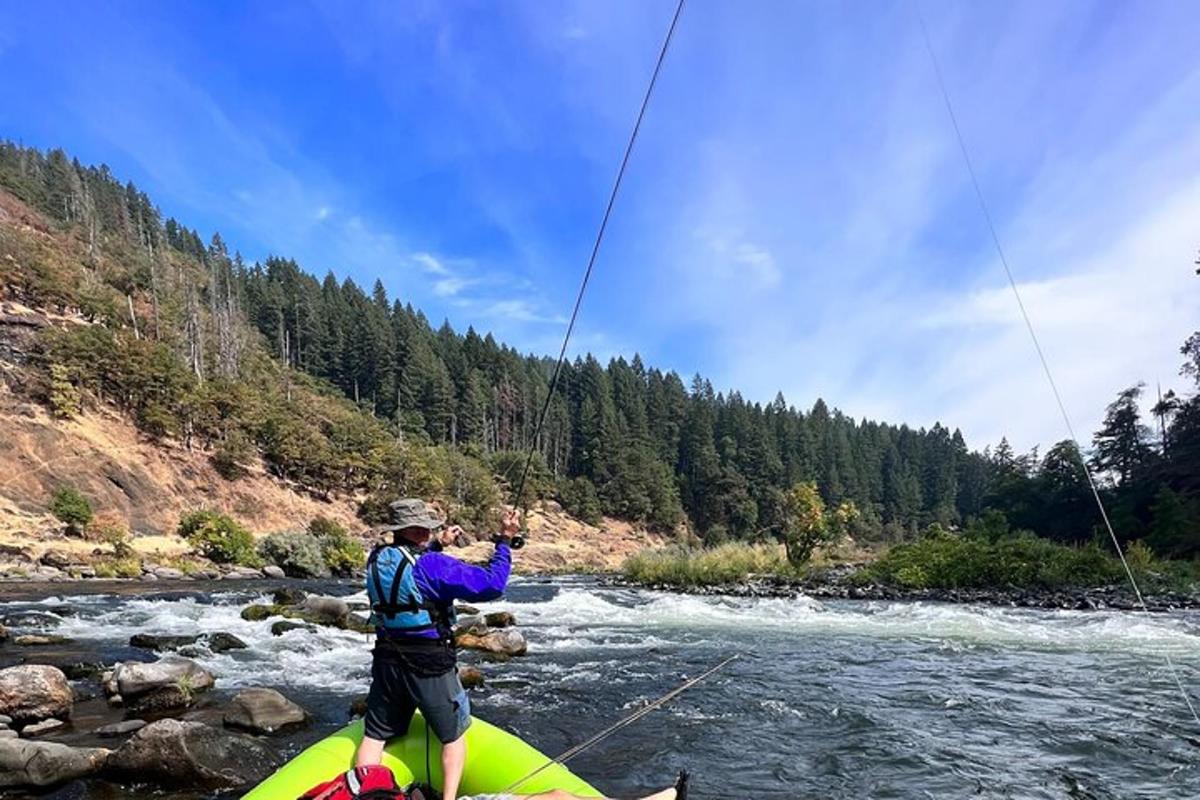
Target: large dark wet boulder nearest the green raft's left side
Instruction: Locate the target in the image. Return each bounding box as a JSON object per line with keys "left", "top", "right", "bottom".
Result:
{"left": 108, "top": 720, "right": 276, "bottom": 789}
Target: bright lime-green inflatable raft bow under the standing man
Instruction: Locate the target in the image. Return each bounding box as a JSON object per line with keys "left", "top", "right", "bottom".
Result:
{"left": 242, "top": 712, "right": 601, "bottom": 800}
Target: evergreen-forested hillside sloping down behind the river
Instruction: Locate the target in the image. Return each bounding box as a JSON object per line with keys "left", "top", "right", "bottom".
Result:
{"left": 0, "top": 144, "right": 1200, "bottom": 552}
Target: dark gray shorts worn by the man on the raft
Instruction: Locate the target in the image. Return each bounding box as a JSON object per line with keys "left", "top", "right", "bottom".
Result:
{"left": 362, "top": 658, "right": 470, "bottom": 745}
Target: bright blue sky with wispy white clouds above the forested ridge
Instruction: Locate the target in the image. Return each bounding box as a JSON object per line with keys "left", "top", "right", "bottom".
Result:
{"left": 0, "top": 0, "right": 1200, "bottom": 446}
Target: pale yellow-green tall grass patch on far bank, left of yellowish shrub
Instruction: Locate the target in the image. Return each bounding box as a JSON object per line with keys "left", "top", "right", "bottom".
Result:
{"left": 622, "top": 542, "right": 798, "bottom": 588}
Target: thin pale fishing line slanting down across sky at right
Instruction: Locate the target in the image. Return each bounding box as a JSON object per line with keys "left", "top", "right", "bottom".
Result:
{"left": 913, "top": 2, "right": 1200, "bottom": 726}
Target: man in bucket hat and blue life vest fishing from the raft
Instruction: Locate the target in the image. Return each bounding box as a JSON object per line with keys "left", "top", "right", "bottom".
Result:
{"left": 355, "top": 499, "right": 521, "bottom": 800}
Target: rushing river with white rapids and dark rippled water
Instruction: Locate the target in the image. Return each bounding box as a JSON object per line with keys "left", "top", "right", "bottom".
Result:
{"left": 0, "top": 578, "right": 1200, "bottom": 800}
